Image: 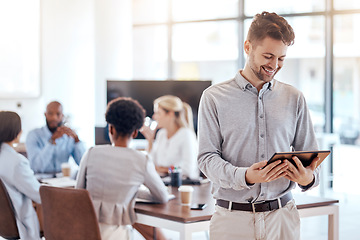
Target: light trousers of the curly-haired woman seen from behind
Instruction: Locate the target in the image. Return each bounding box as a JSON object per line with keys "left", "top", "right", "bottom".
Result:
{"left": 99, "top": 223, "right": 131, "bottom": 240}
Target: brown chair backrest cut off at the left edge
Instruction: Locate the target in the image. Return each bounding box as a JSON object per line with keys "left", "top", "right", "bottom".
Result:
{"left": 0, "top": 179, "right": 20, "bottom": 239}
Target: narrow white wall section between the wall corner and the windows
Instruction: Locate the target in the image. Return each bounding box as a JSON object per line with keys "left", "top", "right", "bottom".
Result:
{"left": 95, "top": 0, "right": 132, "bottom": 126}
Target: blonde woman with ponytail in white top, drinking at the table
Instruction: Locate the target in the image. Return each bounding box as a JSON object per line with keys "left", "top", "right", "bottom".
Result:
{"left": 141, "top": 95, "right": 199, "bottom": 179}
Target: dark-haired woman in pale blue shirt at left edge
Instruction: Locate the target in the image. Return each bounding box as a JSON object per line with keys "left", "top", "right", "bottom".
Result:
{"left": 0, "top": 111, "right": 41, "bottom": 240}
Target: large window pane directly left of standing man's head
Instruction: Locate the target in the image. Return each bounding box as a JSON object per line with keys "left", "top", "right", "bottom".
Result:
{"left": 172, "top": 21, "right": 238, "bottom": 83}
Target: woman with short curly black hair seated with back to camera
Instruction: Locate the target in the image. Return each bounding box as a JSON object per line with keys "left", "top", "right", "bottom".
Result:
{"left": 76, "top": 98, "right": 168, "bottom": 240}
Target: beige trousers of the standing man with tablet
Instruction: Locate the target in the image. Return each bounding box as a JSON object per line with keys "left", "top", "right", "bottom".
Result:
{"left": 210, "top": 200, "right": 300, "bottom": 240}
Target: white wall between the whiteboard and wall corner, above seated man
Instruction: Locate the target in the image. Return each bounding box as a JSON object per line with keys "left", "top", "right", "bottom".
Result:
{"left": 39, "top": 0, "right": 95, "bottom": 146}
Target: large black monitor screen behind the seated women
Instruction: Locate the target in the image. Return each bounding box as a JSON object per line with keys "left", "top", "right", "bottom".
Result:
{"left": 101, "top": 80, "right": 211, "bottom": 139}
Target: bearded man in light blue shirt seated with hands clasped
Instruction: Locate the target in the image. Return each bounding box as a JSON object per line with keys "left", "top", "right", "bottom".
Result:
{"left": 26, "top": 101, "right": 85, "bottom": 174}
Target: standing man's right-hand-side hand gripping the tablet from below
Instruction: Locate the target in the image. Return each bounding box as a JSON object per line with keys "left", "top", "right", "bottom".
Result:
{"left": 284, "top": 156, "right": 320, "bottom": 186}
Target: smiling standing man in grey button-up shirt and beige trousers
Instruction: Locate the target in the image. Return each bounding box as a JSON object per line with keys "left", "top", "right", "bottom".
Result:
{"left": 198, "top": 12, "right": 319, "bottom": 240}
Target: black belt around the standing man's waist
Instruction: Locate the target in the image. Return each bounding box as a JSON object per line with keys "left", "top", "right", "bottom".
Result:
{"left": 216, "top": 193, "right": 292, "bottom": 212}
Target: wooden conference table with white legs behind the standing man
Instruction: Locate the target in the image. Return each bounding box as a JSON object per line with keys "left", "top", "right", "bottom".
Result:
{"left": 135, "top": 183, "right": 339, "bottom": 240}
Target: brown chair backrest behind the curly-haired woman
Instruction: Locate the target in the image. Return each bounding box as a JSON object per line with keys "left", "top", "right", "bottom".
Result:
{"left": 40, "top": 186, "right": 101, "bottom": 240}
